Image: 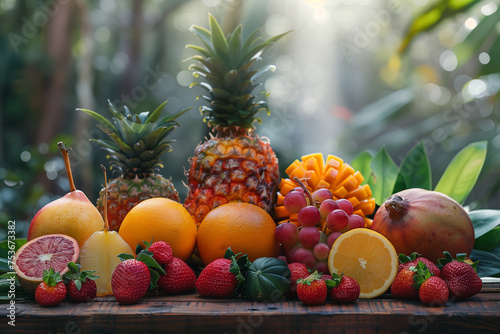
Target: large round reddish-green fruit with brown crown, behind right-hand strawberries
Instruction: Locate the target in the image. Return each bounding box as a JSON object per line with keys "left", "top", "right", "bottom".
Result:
{"left": 371, "top": 188, "right": 474, "bottom": 263}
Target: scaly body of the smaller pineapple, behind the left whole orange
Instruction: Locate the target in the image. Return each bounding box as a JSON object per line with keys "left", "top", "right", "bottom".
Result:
{"left": 97, "top": 174, "right": 180, "bottom": 232}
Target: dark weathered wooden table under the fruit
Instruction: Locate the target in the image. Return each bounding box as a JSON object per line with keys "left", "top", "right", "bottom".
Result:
{"left": 0, "top": 283, "right": 500, "bottom": 334}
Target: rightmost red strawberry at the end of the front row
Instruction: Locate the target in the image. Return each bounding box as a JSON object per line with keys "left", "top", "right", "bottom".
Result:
{"left": 438, "top": 252, "right": 483, "bottom": 299}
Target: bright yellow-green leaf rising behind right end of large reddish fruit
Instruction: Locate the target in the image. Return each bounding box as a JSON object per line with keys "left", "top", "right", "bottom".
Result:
{"left": 434, "top": 141, "right": 487, "bottom": 203}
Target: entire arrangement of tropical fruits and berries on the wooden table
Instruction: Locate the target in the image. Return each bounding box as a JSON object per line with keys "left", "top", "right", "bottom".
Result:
{"left": 5, "top": 16, "right": 498, "bottom": 306}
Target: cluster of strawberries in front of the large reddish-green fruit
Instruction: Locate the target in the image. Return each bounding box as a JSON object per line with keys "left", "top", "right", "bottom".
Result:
{"left": 391, "top": 252, "right": 483, "bottom": 306}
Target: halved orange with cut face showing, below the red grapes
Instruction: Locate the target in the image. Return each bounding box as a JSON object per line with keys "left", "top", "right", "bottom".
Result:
{"left": 328, "top": 228, "right": 399, "bottom": 299}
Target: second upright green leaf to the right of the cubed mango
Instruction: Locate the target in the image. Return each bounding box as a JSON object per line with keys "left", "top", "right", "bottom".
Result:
{"left": 368, "top": 147, "right": 398, "bottom": 205}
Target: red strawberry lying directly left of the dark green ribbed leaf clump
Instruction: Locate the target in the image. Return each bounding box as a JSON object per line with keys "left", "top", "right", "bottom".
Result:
{"left": 196, "top": 258, "right": 242, "bottom": 298}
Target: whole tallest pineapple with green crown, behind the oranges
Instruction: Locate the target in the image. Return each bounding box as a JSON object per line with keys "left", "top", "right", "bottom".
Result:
{"left": 184, "top": 15, "right": 285, "bottom": 224}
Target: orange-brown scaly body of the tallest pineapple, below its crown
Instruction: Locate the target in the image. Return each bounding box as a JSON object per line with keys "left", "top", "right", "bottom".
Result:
{"left": 184, "top": 135, "right": 280, "bottom": 226}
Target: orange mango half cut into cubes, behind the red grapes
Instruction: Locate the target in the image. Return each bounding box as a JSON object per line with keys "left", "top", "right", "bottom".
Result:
{"left": 275, "top": 153, "right": 375, "bottom": 228}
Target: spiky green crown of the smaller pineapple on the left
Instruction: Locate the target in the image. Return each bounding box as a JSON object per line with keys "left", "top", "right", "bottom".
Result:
{"left": 77, "top": 101, "right": 191, "bottom": 175}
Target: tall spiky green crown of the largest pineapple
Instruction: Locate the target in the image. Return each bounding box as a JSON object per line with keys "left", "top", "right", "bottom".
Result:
{"left": 186, "top": 15, "right": 288, "bottom": 129}
